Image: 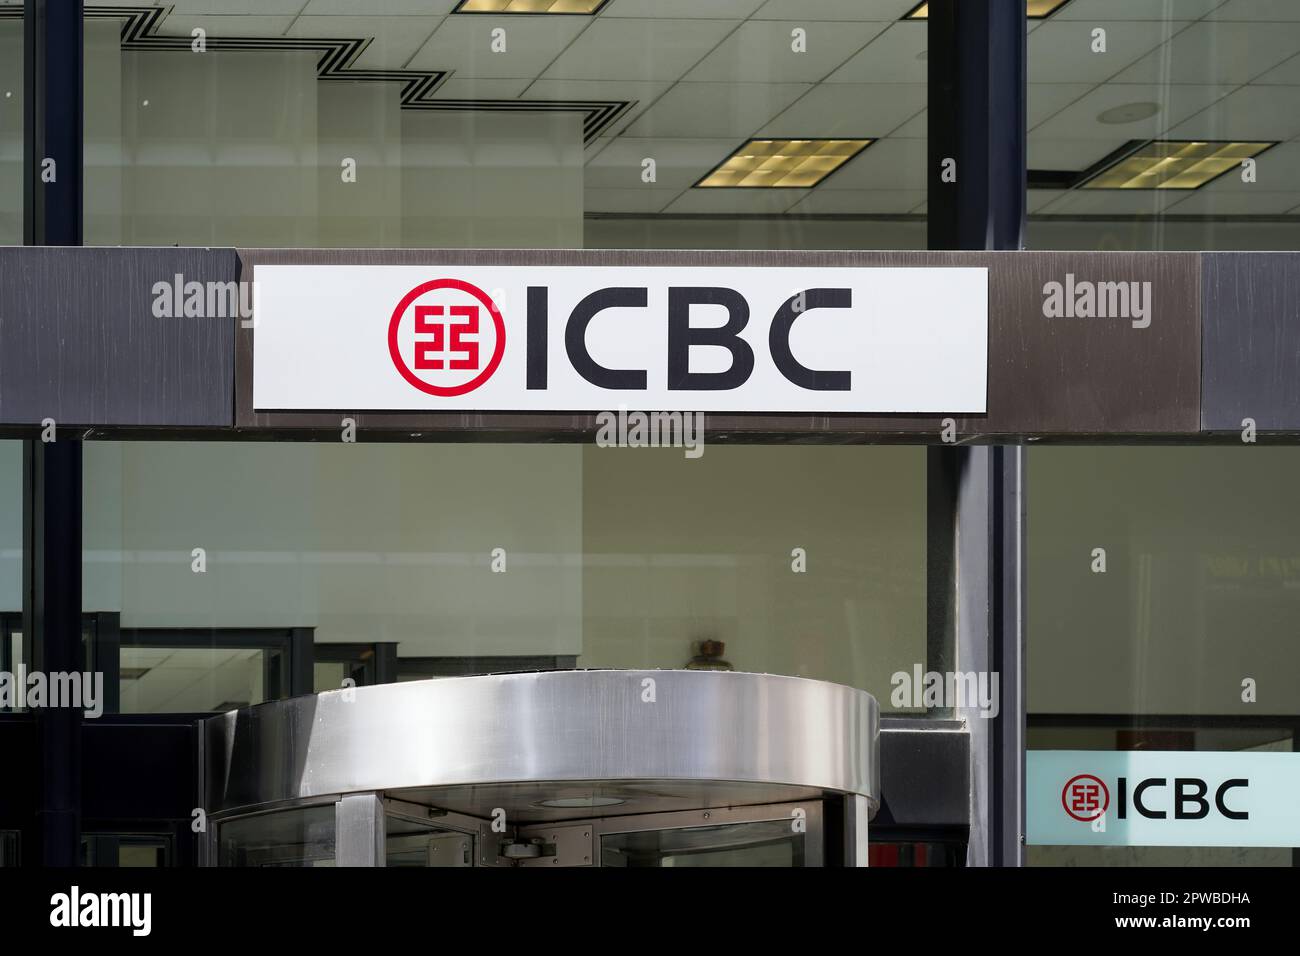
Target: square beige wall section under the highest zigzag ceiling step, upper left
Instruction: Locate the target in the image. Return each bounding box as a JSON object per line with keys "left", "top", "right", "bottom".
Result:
{"left": 121, "top": 51, "right": 319, "bottom": 247}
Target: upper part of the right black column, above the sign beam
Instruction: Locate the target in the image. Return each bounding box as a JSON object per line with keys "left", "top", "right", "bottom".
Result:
{"left": 927, "top": 0, "right": 1028, "bottom": 250}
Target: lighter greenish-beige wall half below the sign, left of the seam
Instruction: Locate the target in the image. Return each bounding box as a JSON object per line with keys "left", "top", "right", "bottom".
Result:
{"left": 83, "top": 442, "right": 582, "bottom": 656}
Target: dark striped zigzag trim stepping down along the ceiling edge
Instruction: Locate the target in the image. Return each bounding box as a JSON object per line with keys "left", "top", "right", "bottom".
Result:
{"left": 0, "top": 7, "right": 634, "bottom": 143}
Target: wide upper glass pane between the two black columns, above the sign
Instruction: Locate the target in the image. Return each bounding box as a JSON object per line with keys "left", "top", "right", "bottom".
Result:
{"left": 85, "top": 0, "right": 927, "bottom": 248}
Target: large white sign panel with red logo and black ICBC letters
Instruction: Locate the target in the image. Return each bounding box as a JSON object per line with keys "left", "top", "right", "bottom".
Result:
{"left": 254, "top": 265, "right": 988, "bottom": 414}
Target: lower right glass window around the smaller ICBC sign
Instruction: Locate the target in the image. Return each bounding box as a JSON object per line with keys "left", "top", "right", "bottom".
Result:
{"left": 1027, "top": 446, "right": 1300, "bottom": 865}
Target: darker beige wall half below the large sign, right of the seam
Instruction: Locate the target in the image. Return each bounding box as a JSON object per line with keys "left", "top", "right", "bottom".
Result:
{"left": 579, "top": 445, "right": 926, "bottom": 708}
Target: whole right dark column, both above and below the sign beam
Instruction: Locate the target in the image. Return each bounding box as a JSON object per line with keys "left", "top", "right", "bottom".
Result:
{"left": 927, "top": 0, "right": 1027, "bottom": 866}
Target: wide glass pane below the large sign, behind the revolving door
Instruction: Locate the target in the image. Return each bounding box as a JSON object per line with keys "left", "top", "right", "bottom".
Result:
{"left": 83, "top": 442, "right": 944, "bottom": 713}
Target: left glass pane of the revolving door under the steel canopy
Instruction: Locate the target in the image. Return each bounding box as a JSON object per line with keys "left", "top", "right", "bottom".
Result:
{"left": 217, "top": 804, "right": 334, "bottom": 866}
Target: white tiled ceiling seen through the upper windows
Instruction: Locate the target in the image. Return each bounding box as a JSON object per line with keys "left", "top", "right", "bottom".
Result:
{"left": 0, "top": 0, "right": 1300, "bottom": 222}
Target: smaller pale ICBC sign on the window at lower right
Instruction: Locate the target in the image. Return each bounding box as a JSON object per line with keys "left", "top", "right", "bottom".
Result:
{"left": 1026, "top": 750, "right": 1300, "bottom": 847}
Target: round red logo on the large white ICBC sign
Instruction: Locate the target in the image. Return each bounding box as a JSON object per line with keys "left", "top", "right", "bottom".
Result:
{"left": 389, "top": 278, "right": 506, "bottom": 395}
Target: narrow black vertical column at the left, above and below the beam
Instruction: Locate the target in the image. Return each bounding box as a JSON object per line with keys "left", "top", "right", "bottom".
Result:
{"left": 23, "top": 0, "right": 83, "bottom": 866}
